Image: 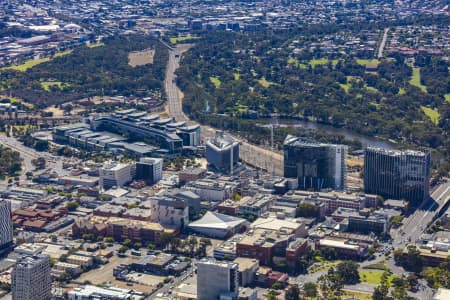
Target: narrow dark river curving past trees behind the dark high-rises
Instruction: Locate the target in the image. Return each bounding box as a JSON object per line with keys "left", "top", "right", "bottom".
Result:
{"left": 268, "top": 118, "right": 397, "bottom": 150}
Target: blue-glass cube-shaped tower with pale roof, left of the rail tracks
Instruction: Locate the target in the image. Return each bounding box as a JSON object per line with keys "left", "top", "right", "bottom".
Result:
{"left": 206, "top": 131, "right": 239, "bottom": 174}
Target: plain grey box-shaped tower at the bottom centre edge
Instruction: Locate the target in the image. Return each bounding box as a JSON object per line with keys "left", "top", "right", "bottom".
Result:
{"left": 197, "top": 259, "right": 239, "bottom": 300}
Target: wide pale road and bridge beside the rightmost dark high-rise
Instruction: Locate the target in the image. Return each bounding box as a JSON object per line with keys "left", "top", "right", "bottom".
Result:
{"left": 391, "top": 181, "right": 450, "bottom": 248}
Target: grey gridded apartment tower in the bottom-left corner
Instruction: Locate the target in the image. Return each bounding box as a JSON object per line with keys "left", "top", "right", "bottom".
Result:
{"left": 11, "top": 254, "right": 52, "bottom": 300}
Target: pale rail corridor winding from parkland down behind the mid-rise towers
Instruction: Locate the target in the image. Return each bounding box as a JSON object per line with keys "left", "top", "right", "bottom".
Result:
{"left": 164, "top": 44, "right": 284, "bottom": 176}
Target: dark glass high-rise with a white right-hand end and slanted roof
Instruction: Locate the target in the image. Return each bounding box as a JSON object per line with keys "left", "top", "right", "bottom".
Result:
{"left": 284, "top": 135, "right": 347, "bottom": 191}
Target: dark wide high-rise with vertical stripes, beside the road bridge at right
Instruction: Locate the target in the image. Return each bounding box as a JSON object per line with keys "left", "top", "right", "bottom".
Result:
{"left": 364, "top": 148, "right": 431, "bottom": 204}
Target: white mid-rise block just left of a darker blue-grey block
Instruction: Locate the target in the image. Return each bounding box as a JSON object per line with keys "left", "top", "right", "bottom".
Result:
{"left": 99, "top": 163, "right": 136, "bottom": 189}
